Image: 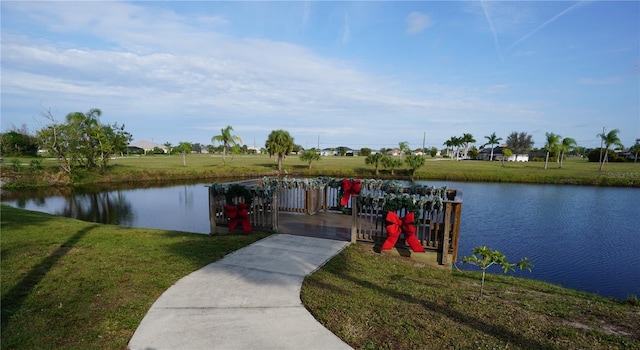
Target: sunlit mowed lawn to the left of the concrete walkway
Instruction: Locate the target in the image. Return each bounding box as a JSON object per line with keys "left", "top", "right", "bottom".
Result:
{"left": 0, "top": 205, "right": 266, "bottom": 349}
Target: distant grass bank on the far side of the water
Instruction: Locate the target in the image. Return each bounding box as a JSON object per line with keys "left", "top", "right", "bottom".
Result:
{"left": 2, "top": 154, "right": 640, "bottom": 189}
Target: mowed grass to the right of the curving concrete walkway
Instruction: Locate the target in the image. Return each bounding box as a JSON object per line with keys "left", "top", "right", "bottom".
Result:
{"left": 301, "top": 244, "right": 640, "bottom": 349}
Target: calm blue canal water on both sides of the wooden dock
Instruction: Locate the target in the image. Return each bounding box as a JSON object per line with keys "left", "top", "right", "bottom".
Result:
{"left": 2, "top": 181, "right": 640, "bottom": 299}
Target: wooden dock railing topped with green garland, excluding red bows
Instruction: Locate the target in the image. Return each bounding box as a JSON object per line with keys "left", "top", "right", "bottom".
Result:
{"left": 209, "top": 177, "right": 462, "bottom": 264}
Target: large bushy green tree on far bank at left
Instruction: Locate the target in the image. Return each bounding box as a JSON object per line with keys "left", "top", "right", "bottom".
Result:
{"left": 37, "top": 108, "right": 132, "bottom": 173}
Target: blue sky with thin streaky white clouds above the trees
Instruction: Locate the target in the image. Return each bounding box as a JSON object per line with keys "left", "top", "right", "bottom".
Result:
{"left": 0, "top": 1, "right": 640, "bottom": 149}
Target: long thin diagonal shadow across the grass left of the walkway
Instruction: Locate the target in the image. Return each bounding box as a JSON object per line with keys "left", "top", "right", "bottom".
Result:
{"left": 0, "top": 225, "right": 99, "bottom": 329}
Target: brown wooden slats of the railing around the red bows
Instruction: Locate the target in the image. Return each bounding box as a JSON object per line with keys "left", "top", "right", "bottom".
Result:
{"left": 209, "top": 180, "right": 462, "bottom": 264}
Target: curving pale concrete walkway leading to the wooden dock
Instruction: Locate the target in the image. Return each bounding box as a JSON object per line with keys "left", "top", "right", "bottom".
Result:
{"left": 129, "top": 234, "right": 350, "bottom": 350}
